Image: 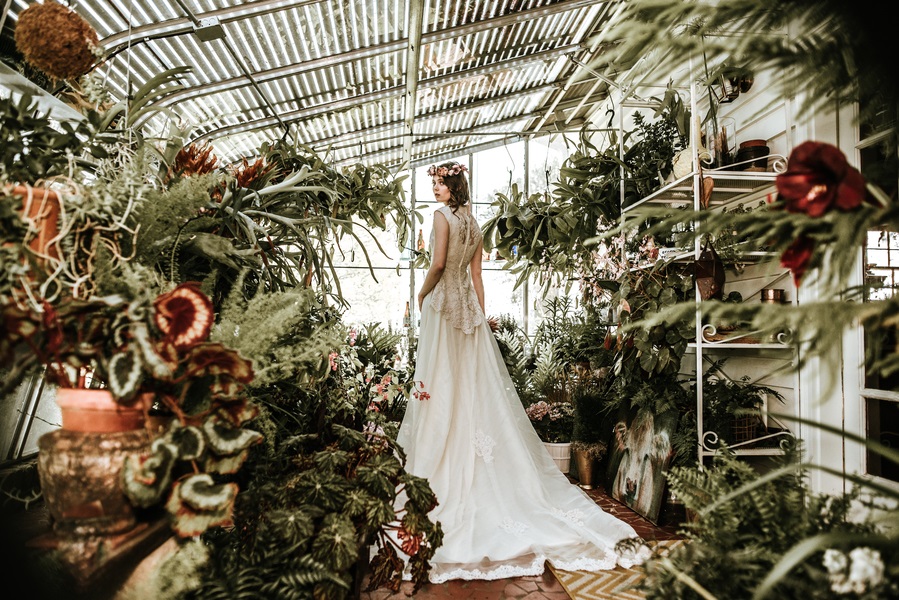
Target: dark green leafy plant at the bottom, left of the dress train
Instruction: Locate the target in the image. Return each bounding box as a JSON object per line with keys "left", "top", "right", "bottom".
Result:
{"left": 184, "top": 412, "right": 442, "bottom": 599}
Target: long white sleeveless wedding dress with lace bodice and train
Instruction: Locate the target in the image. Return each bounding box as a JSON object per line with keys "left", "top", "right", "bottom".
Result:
{"left": 398, "top": 206, "right": 639, "bottom": 583}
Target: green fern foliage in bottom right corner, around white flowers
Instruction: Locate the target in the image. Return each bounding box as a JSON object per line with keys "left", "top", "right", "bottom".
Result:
{"left": 639, "top": 438, "right": 899, "bottom": 600}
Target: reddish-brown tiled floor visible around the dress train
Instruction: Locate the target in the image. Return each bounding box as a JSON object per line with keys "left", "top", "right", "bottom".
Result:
{"left": 361, "top": 478, "right": 679, "bottom": 600}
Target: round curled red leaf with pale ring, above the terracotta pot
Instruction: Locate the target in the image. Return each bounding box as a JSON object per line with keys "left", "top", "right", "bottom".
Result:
{"left": 153, "top": 281, "right": 215, "bottom": 348}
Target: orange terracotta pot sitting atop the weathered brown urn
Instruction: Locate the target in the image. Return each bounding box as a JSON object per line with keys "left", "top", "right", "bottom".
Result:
{"left": 56, "top": 388, "right": 144, "bottom": 433}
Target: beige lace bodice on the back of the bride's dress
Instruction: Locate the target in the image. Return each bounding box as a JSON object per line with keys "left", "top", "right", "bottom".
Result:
{"left": 431, "top": 206, "right": 484, "bottom": 333}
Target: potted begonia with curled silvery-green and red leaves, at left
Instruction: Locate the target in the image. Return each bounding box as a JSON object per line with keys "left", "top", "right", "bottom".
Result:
{"left": 0, "top": 283, "right": 261, "bottom": 537}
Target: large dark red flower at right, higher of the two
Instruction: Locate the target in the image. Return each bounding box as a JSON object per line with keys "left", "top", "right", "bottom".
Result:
{"left": 777, "top": 142, "right": 865, "bottom": 217}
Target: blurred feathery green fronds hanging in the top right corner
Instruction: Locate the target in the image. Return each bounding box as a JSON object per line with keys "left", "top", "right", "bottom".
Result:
{"left": 608, "top": 0, "right": 899, "bottom": 155}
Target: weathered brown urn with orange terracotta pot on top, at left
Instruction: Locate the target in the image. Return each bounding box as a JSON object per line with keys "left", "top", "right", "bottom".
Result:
{"left": 38, "top": 388, "right": 150, "bottom": 537}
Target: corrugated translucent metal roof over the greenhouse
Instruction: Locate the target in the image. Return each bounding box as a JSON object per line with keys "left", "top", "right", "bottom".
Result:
{"left": 3, "top": 0, "right": 619, "bottom": 166}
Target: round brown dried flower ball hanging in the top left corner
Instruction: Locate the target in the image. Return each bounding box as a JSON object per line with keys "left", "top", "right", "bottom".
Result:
{"left": 15, "top": 1, "right": 100, "bottom": 79}
